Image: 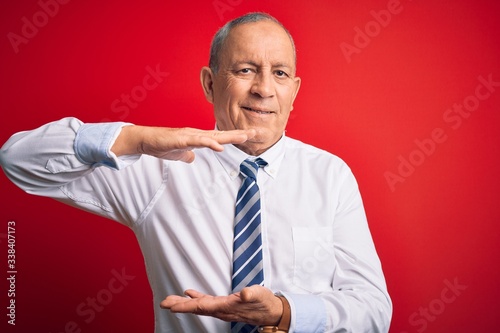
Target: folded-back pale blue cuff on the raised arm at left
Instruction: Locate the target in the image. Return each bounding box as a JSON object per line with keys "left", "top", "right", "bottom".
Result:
{"left": 73, "top": 122, "right": 140, "bottom": 170}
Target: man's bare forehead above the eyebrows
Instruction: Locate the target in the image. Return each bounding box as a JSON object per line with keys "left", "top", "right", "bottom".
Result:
{"left": 222, "top": 20, "right": 295, "bottom": 67}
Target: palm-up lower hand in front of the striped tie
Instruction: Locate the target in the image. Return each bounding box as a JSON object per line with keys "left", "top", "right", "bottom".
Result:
{"left": 160, "top": 285, "right": 283, "bottom": 326}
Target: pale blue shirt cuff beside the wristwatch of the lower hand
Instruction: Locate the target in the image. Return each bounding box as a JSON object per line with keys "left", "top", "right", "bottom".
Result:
{"left": 277, "top": 292, "right": 326, "bottom": 333}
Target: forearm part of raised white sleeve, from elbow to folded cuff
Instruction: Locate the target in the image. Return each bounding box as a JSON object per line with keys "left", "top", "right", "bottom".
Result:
{"left": 0, "top": 117, "right": 139, "bottom": 192}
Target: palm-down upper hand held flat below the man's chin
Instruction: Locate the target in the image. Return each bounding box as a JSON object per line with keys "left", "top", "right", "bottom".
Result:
{"left": 111, "top": 126, "right": 255, "bottom": 163}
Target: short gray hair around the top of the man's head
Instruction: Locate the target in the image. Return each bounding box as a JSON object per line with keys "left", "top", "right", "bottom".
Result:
{"left": 209, "top": 12, "right": 297, "bottom": 74}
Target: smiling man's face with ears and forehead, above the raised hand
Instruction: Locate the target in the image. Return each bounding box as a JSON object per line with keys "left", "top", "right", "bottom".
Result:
{"left": 202, "top": 20, "right": 300, "bottom": 155}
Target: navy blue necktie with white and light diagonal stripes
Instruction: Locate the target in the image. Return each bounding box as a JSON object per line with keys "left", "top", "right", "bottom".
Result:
{"left": 231, "top": 158, "right": 267, "bottom": 333}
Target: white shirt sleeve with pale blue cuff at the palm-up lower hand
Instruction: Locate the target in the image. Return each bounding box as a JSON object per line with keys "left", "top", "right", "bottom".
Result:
{"left": 281, "top": 160, "right": 392, "bottom": 333}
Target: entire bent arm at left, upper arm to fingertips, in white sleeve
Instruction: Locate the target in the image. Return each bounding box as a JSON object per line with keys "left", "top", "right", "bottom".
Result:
{"left": 0, "top": 118, "right": 252, "bottom": 222}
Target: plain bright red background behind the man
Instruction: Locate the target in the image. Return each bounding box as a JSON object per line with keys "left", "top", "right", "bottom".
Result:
{"left": 0, "top": 0, "right": 500, "bottom": 333}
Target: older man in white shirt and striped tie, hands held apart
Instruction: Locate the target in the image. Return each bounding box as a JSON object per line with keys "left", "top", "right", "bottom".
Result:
{"left": 0, "top": 13, "right": 392, "bottom": 333}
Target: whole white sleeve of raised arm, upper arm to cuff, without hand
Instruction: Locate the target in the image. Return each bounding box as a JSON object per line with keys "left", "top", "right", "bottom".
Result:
{"left": 0, "top": 117, "right": 156, "bottom": 226}
